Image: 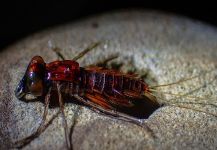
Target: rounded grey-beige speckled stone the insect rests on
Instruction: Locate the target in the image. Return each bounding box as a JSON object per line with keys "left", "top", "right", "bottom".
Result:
{"left": 0, "top": 11, "right": 217, "bottom": 150}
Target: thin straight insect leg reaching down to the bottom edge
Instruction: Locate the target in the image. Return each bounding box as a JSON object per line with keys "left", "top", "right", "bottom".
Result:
{"left": 57, "top": 83, "right": 72, "bottom": 149}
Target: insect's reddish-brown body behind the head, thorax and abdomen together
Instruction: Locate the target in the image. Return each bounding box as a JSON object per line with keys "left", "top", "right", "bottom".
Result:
{"left": 46, "top": 60, "right": 159, "bottom": 118}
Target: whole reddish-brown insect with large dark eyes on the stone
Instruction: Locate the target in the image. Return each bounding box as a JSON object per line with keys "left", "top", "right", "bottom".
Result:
{"left": 14, "top": 43, "right": 216, "bottom": 149}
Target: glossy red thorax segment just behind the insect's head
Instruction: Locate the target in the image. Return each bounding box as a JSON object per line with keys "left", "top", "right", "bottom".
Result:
{"left": 46, "top": 60, "right": 79, "bottom": 81}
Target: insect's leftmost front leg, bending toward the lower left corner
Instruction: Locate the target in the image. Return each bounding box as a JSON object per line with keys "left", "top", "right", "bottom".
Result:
{"left": 13, "top": 88, "right": 57, "bottom": 148}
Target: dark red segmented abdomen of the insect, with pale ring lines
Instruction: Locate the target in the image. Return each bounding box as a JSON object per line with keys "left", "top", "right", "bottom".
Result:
{"left": 81, "top": 68, "right": 148, "bottom": 101}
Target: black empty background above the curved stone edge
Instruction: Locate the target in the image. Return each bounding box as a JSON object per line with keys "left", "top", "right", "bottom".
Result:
{"left": 0, "top": 0, "right": 217, "bottom": 50}
